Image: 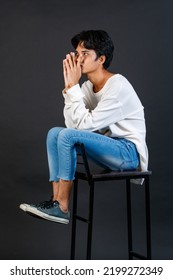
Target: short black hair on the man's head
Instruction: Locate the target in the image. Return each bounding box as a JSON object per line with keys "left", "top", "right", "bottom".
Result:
{"left": 71, "top": 30, "right": 114, "bottom": 69}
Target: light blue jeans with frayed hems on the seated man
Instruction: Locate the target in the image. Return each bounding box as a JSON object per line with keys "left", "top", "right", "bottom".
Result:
{"left": 47, "top": 127, "right": 139, "bottom": 182}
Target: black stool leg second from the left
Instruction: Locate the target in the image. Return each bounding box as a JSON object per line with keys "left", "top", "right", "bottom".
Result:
{"left": 87, "top": 181, "right": 94, "bottom": 260}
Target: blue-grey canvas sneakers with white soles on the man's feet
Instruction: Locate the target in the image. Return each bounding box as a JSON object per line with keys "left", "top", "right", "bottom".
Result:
{"left": 20, "top": 200, "right": 70, "bottom": 224}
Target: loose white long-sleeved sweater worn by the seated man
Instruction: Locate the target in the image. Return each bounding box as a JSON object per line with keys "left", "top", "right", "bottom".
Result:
{"left": 63, "top": 74, "right": 148, "bottom": 171}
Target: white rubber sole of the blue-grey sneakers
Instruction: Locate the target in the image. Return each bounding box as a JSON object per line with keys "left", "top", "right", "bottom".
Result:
{"left": 20, "top": 203, "right": 69, "bottom": 224}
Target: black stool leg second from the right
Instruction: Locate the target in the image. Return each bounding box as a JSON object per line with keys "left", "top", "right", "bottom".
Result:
{"left": 126, "top": 179, "right": 132, "bottom": 259}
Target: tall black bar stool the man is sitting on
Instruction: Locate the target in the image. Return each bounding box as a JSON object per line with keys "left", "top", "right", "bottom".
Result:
{"left": 71, "top": 144, "right": 152, "bottom": 259}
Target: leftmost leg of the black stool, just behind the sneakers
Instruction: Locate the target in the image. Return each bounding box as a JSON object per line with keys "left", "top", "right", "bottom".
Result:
{"left": 71, "top": 178, "right": 78, "bottom": 260}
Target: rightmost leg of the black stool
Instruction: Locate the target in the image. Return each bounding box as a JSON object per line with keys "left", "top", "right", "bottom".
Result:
{"left": 145, "top": 176, "right": 151, "bottom": 260}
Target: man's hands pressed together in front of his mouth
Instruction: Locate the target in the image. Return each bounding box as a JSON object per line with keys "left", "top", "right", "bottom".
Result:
{"left": 63, "top": 53, "right": 82, "bottom": 89}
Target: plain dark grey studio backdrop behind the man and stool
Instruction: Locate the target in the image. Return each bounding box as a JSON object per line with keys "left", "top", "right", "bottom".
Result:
{"left": 0, "top": 0, "right": 173, "bottom": 259}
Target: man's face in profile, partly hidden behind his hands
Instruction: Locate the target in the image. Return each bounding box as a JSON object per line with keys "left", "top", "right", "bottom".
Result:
{"left": 76, "top": 44, "right": 100, "bottom": 74}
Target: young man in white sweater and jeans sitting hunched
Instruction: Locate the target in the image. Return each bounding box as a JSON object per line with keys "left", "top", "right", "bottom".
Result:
{"left": 20, "top": 30, "right": 148, "bottom": 224}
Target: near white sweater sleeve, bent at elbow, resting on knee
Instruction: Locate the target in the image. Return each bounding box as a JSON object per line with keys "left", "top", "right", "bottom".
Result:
{"left": 63, "top": 81, "right": 123, "bottom": 131}
